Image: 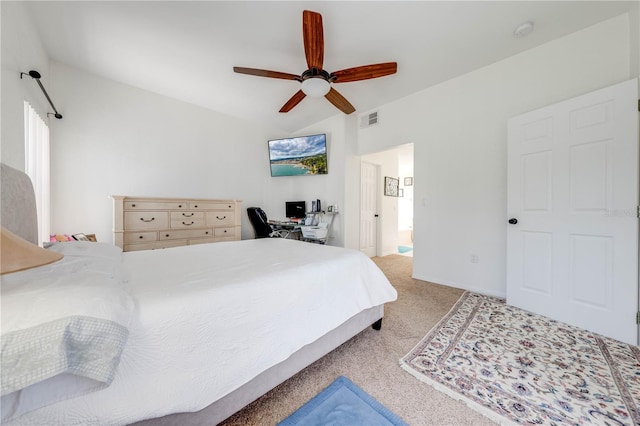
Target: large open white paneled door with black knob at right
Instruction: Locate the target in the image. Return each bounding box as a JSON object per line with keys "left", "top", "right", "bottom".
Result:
{"left": 506, "top": 79, "right": 639, "bottom": 344}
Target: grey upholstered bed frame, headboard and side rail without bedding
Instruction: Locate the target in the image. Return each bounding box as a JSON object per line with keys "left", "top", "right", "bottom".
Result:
{"left": 0, "top": 164, "right": 384, "bottom": 425}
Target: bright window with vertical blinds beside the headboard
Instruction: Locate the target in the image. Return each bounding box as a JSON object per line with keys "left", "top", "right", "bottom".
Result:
{"left": 24, "top": 101, "right": 51, "bottom": 242}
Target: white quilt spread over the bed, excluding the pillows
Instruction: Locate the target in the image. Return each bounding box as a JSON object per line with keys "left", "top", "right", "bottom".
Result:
{"left": 13, "top": 239, "right": 397, "bottom": 425}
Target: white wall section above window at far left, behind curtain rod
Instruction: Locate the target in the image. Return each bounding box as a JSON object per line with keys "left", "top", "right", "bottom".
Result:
{"left": 0, "top": 1, "right": 50, "bottom": 170}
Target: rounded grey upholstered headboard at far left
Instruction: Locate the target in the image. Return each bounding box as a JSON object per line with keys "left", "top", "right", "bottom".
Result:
{"left": 0, "top": 164, "right": 38, "bottom": 244}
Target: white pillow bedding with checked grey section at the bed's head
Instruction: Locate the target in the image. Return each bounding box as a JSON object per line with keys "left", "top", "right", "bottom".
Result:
{"left": 0, "top": 242, "right": 134, "bottom": 423}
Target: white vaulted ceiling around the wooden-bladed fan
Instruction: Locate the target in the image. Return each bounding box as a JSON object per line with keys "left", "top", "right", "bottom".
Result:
{"left": 28, "top": 1, "right": 634, "bottom": 132}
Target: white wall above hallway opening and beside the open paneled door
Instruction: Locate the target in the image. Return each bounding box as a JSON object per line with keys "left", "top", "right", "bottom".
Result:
{"left": 358, "top": 15, "right": 632, "bottom": 296}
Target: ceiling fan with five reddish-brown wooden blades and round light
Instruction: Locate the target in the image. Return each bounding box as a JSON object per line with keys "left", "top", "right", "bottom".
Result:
{"left": 233, "top": 10, "right": 398, "bottom": 114}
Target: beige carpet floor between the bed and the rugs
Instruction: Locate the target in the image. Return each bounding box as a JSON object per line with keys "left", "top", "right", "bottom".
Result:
{"left": 221, "top": 255, "right": 494, "bottom": 426}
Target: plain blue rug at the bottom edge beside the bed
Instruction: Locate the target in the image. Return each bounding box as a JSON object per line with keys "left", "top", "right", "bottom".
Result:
{"left": 278, "top": 376, "right": 408, "bottom": 426}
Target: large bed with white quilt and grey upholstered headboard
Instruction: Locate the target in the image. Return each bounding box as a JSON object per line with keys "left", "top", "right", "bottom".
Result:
{"left": 1, "top": 165, "right": 397, "bottom": 425}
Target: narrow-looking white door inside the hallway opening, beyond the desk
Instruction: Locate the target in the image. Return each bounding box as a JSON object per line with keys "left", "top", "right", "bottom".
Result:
{"left": 360, "top": 161, "right": 378, "bottom": 257}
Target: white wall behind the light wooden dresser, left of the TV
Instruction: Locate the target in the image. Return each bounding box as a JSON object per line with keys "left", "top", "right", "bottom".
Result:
{"left": 50, "top": 62, "right": 288, "bottom": 242}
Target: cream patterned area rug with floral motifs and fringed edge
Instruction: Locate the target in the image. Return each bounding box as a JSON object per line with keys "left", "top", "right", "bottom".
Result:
{"left": 400, "top": 292, "right": 640, "bottom": 425}
